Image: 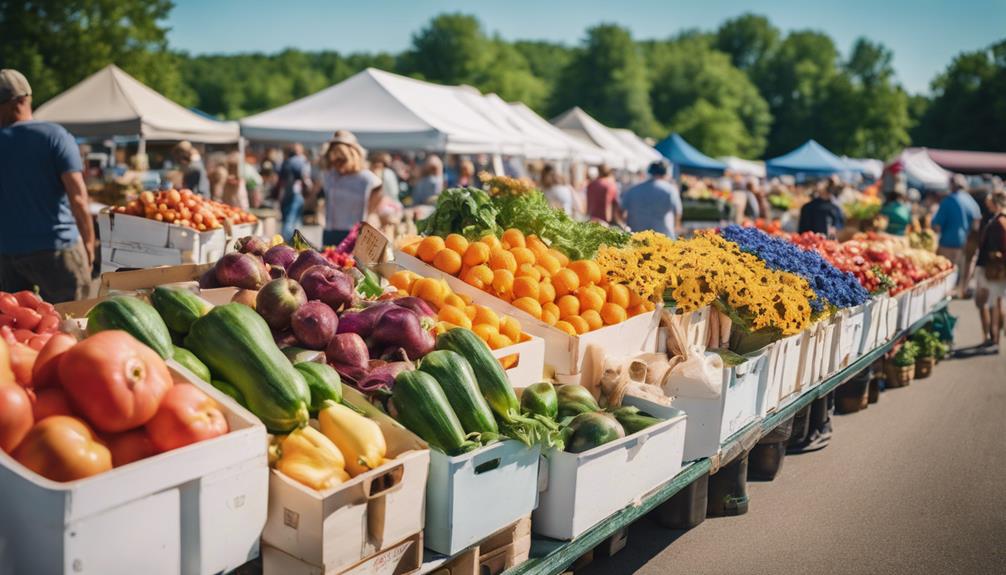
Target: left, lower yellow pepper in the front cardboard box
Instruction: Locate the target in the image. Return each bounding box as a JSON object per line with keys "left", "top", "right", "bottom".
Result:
{"left": 275, "top": 426, "right": 349, "bottom": 491}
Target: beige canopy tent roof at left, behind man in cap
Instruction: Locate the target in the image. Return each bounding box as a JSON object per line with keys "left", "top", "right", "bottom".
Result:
{"left": 34, "top": 64, "right": 239, "bottom": 145}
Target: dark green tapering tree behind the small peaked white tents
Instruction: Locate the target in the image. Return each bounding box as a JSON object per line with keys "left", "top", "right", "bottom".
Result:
{"left": 550, "top": 24, "right": 661, "bottom": 136}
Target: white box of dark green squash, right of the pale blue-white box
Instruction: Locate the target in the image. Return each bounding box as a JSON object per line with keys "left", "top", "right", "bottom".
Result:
{"left": 531, "top": 398, "right": 691, "bottom": 540}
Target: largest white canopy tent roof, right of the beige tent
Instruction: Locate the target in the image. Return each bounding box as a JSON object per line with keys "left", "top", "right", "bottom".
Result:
{"left": 240, "top": 68, "right": 507, "bottom": 154}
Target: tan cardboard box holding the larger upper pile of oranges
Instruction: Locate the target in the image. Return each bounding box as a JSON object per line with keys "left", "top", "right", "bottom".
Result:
{"left": 394, "top": 251, "right": 660, "bottom": 383}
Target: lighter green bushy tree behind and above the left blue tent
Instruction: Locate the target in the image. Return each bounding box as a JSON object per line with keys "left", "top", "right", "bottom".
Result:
{"left": 646, "top": 36, "right": 772, "bottom": 158}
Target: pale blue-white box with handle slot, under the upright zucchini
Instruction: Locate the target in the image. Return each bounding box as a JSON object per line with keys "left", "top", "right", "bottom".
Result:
{"left": 425, "top": 440, "right": 540, "bottom": 555}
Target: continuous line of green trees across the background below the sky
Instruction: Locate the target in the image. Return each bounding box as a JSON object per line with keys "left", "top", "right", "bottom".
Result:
{"left": 0, "top": 0, "right": 1006, "bottom": 159}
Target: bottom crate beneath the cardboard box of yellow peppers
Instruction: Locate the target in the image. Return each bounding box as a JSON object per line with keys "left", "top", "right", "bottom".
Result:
{"left": 262, "top": 533, "right": 423, "bottom": 575}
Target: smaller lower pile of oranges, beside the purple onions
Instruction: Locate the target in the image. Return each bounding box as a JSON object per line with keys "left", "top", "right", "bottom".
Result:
{"left": 388, "top": 269, "right": 530, "bottom": 350}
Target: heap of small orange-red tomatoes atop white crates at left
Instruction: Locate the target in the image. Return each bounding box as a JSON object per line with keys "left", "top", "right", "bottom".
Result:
{"left": 113, "top": 190, "right": 258, "bottom": 231}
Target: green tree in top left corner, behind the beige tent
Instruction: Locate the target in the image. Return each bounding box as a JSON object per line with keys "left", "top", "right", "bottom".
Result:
{"left": 0, "top": 0, "right": 193, "bottom": 105}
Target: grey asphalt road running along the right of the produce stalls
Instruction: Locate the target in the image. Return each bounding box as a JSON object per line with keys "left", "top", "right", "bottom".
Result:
{"left": 582, "top": 302, "right": 1006, "bottom": 575}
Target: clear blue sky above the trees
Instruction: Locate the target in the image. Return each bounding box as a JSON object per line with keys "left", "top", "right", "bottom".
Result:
{"left": 168, "top": 0, "right": 1006, "bottom": 91}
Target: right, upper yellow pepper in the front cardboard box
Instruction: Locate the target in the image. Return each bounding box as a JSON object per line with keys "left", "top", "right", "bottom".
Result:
{"left": 318, "top": 401, "right": 387, "bottom": 477}
